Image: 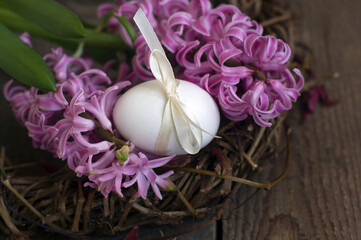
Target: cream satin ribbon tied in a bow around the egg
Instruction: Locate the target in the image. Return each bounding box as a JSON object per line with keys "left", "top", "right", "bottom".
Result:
{"left": 134, "top": 8, "right": 213, "bottom": 155}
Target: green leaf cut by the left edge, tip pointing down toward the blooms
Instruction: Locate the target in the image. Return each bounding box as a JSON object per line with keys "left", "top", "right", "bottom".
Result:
{"left": 0, "top": 24, "right": 56, "bottom": 91}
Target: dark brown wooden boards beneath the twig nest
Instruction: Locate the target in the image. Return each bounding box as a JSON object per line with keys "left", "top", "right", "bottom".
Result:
{"left": 0, "top": 0, "right": 361, "bottom": 240}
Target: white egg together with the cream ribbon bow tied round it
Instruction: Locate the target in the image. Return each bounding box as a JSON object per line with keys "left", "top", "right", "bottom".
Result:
{"left": 113, "top": 9, "right": 220, "bottom": 155}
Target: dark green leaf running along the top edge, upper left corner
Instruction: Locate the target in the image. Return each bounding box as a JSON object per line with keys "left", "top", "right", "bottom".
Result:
{"left": 0, "top": 0, "right": 85, "bottom": 38}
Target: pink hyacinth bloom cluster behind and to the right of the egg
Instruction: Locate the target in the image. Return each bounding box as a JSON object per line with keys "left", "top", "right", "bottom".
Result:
{"left": 98, "top": 0, "right": 304, "bottom": 126}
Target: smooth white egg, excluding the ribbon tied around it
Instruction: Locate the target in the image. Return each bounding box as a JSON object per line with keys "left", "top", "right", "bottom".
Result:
{"left": 113, "top": 80, "right": 220, "bottom": 155}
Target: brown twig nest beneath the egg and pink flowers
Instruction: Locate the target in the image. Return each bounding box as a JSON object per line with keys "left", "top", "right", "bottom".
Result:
{"left": 0, "top": 0, "right": 294, "bottom": 239}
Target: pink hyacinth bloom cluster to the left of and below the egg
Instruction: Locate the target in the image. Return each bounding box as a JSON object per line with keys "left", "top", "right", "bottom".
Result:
{"left": 4, "top": 43, "right": 174, "bottom": 199}
